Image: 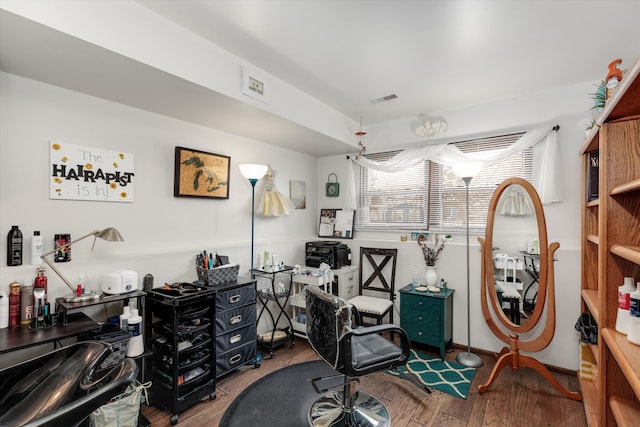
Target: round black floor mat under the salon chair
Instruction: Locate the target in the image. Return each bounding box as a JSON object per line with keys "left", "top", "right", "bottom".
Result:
{"left": 220, "top": 360, "right": 338, "bottom": 427}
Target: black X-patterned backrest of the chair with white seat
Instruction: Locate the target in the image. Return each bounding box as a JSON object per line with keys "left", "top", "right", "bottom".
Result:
{"left": 358, "top": 248, "right": 398, "bottom": 301}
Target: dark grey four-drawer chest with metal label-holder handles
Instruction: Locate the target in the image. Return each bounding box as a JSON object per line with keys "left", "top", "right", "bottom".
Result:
{"left": 215, "top": 278, "right": 258, "bottom": 377}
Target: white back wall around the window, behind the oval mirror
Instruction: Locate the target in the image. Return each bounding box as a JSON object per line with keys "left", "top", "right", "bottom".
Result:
{"left": 317, "top": 83, "right": 592, "bottom": 369}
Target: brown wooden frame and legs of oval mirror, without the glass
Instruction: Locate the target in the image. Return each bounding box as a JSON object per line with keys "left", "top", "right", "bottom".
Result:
{"left": 478, "top": 178, "right": 582, "bottom": 400}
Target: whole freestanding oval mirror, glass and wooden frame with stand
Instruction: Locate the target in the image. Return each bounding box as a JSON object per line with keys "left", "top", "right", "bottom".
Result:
{"left": 478, "top": 178, "right": 582, "bottom": 400}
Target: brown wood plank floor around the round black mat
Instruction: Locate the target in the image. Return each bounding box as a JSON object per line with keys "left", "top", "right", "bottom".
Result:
{"left": 142, "top": 340, "right": 587, "bottom": 427}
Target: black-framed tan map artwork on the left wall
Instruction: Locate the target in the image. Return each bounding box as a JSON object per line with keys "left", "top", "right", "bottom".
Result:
{"left": 173, "top": 147, "right": 231, "bottom": 199}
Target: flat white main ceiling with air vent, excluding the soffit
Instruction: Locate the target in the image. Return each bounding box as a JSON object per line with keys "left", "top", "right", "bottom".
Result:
{"left": 138, "top": 0, "right": 640, "bottom": 125}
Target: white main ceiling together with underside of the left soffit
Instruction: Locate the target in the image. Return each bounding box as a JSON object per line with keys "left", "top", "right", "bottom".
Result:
{"left": 0, "top": 0, "right": 640, "bottom": 157}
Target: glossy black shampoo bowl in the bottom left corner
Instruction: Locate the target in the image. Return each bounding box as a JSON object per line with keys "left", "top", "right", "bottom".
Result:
{"left": 0, "top": 341, "right": 137, "bottom": 427}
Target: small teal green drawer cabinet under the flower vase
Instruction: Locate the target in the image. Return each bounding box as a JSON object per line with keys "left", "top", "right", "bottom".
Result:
{"left": 400, "top": 285, "right": 455, "bottom": 360}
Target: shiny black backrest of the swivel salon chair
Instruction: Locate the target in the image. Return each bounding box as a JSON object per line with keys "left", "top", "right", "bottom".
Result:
{"left": 305, "top": 285, "right": 351, "bottom": 370}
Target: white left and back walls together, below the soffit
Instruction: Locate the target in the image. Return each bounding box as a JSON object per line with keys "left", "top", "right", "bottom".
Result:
{"left": 0, "top": 73, "right": 590, "bottom": 369}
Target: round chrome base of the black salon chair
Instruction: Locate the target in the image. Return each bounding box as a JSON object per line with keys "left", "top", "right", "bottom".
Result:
{"left": 308, "top": 391, "right": 391, "bottom": 427}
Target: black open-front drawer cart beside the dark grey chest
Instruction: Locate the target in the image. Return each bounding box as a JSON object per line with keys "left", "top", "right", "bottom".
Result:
{"left": 146, "top": 283, "right": 216, "bottom": 425}
